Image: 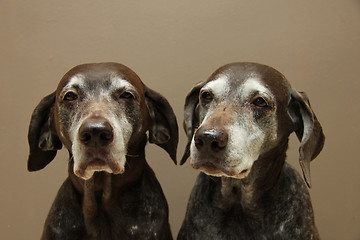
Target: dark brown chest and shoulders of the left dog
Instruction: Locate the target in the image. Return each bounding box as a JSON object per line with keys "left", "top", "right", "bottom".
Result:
{"left": 42, "top": 162, "right": 172, "bottom": 240}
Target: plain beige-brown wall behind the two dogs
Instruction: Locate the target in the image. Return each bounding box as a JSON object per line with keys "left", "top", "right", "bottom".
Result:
{"left": 0, "top": 0, "right": 360, "bottom": 240}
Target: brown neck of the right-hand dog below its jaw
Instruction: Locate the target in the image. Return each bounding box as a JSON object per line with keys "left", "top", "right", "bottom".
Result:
{"left": 220, "top": 140, "right": 288, "bottom": 217}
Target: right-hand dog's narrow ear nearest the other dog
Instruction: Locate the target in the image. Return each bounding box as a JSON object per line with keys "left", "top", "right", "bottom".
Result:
{"left": 180, "top": 82, "right": 205, "bottom": 165}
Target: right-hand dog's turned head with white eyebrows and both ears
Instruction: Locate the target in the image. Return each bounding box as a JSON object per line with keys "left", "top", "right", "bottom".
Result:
{"left": 181, "top": 63, "right": 324, "bottom": 186}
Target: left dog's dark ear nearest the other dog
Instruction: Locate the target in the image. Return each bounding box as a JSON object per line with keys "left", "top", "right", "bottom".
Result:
{"left": 144, "top": 86, "right": 179, "bottom": 164}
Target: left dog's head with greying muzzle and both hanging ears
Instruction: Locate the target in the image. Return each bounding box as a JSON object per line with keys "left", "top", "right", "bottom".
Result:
{"left": 28, "top": 63, "right": 178, "bottom": 179}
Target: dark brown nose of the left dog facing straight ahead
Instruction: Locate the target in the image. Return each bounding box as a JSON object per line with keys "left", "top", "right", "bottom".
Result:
{"left": 79, "top": 119, "right": 114, "bottom": 147}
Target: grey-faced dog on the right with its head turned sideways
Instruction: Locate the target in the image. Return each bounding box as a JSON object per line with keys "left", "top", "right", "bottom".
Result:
{"left": 178, "top": 63, "right": 324, "bottom": 240}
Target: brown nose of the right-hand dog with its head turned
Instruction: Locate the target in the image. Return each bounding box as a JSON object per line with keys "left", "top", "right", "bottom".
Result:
{"left": 194, "top": 127, "right": 228, "bottom": 154}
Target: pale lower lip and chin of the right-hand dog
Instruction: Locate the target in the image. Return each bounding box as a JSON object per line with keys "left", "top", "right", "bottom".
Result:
{"left": 190, "top": 161, "right": 251, "bottom": 179}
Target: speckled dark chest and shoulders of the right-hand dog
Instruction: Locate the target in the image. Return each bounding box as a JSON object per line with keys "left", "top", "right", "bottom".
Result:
{"left": 177, "top": 164, "right": 319, "bottom": 240}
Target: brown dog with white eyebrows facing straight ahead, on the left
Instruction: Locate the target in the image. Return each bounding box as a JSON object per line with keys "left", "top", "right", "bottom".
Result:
{"left": 28, "top": 63, "right": 178, "bottom": 239}
